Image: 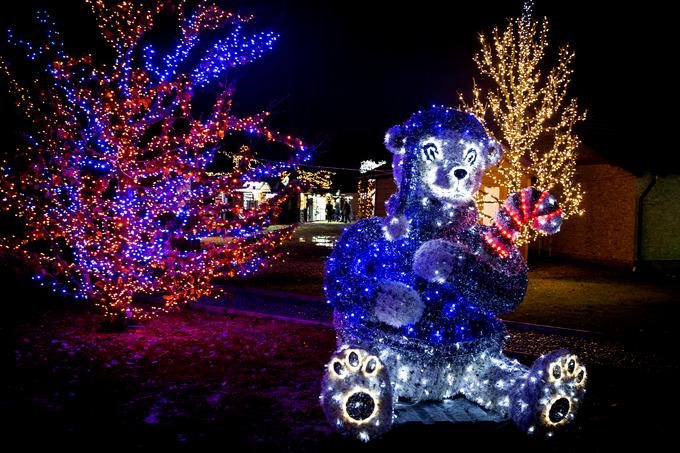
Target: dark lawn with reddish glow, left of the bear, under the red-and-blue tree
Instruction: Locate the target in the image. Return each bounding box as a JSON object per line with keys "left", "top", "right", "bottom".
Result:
{"left": 2, "top": 302, "right": 335, "bottom": 451}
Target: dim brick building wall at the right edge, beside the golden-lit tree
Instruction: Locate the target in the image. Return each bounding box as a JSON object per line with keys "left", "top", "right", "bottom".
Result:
{"left": 531, "top": 148, "right": 680, "bottom": 269}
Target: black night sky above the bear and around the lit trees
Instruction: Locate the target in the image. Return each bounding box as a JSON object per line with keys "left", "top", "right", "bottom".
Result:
{"left": 2, "top": 0, "right": 668, "bottom": 180}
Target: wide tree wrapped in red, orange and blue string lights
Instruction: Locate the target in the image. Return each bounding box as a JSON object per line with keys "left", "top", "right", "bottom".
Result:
{"left": 0, "top": 0, "right": 310, "bottom": 319}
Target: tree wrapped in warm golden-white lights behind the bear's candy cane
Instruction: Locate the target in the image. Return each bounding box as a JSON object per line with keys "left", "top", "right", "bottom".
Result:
{"left": 460, "top": 2, "right": 585, "bottom": 241}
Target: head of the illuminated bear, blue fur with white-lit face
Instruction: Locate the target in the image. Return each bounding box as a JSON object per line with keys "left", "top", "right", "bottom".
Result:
{"left": 385, "top": 106, "right": 502, "bottom": 236}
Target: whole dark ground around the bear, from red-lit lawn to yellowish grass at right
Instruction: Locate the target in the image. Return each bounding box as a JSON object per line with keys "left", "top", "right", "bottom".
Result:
{"left": 0, "top": 224, "right": 680, "bottom": 452}
